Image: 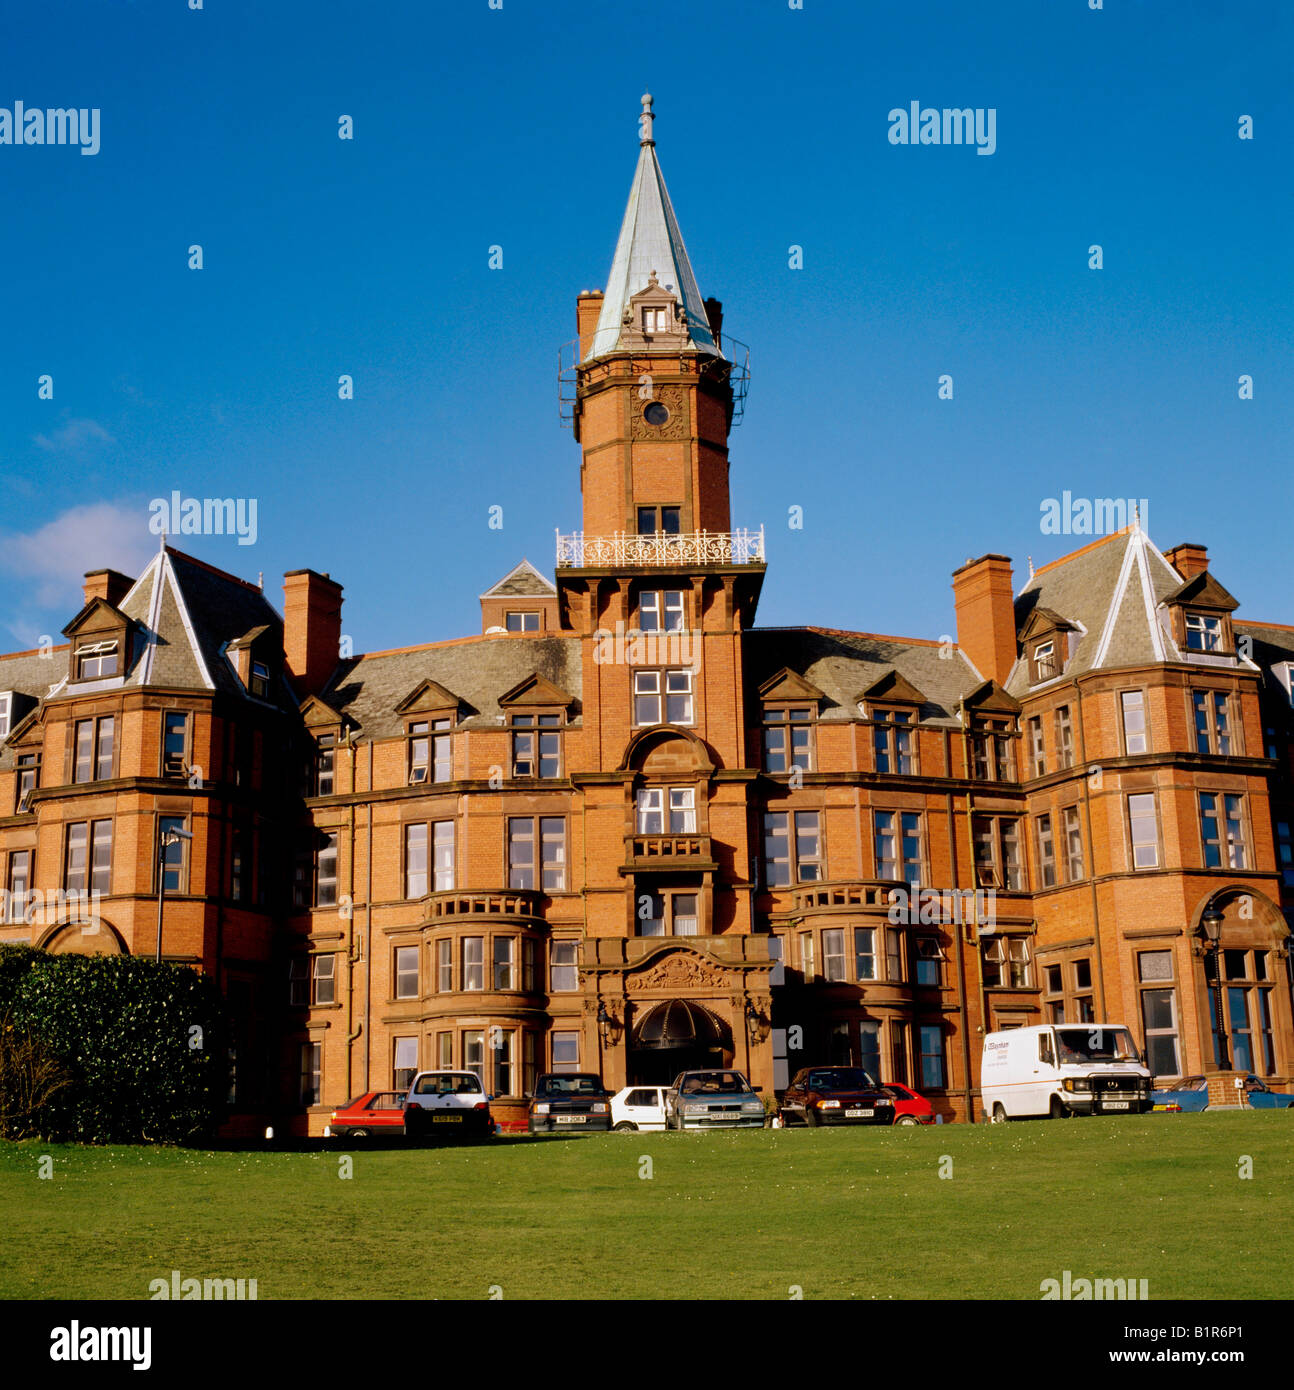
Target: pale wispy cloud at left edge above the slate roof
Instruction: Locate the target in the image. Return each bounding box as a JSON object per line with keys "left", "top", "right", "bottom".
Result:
{"left": 0, "top": 502, "right": 157, "bottom": 648}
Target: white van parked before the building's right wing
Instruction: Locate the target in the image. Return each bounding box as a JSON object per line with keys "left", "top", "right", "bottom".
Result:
{"left": 980, "top": 1023, "right": 1154, "bottom": 1123}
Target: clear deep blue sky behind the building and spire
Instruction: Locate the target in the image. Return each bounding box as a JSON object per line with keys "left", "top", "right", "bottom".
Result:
{"left": 0, "top": 0, "right": 1294, "bottom": 651}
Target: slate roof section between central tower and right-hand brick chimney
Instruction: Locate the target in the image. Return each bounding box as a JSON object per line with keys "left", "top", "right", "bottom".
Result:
{"left": 742, "top": 627, "right": 983, "bottom": 727}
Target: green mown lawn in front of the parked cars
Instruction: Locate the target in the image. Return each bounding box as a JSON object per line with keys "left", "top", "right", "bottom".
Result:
{"left": 0, "top": 1112, "right": 1294, "bottom": 1300}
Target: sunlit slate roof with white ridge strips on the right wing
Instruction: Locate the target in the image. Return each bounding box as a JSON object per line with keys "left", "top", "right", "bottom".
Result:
{"left": 1006, "top": 525, "right": 1181, "bottom": 699}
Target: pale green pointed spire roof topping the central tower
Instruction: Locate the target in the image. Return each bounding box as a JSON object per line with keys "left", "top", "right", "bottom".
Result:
{"left": 585, "top": 96, "right": 723, "bottom": 360}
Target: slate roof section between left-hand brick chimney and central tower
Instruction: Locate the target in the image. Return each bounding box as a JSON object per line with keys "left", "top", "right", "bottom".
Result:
{"left": 320, "top": 632, "right": 582, "bottom": 738}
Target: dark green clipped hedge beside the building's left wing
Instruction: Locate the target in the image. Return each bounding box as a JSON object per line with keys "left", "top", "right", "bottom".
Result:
{"left": 0, "top": 945, "right": 229, "bottom": 1144}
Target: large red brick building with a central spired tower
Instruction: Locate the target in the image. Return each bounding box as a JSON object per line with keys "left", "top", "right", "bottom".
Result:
{"left": 0, "top": 104, "right": 1294, "bottom": 1133}
